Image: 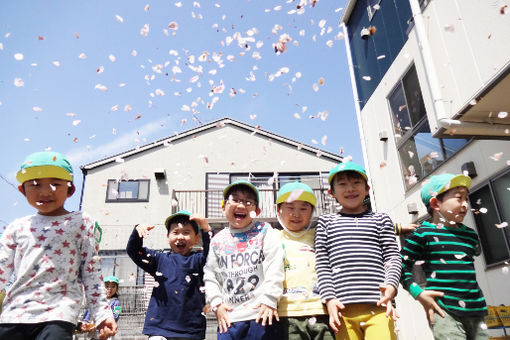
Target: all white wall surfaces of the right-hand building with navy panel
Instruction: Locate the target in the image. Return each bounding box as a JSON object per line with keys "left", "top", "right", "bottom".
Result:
{"left": 352, "top": 0, "right": 510, "bottom": 340}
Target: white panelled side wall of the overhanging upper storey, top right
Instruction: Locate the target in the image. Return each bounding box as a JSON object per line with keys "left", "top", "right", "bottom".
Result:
{"left": 418, "top": 0, "right": 510, "bottom": 131}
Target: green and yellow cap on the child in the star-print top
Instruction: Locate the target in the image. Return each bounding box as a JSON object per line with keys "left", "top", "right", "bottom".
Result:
{"left": 16, "top": 151, "right": 73, "bottom": 184}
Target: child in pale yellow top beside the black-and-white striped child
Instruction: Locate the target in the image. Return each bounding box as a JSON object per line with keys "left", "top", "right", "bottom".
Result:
{"left": 276, "top": 182, "right": 335, "bottom": 340}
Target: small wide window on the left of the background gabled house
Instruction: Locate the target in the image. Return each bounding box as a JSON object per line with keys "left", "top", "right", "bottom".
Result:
{"left": 106, "top": 179, "right": 150, "bottom": 202}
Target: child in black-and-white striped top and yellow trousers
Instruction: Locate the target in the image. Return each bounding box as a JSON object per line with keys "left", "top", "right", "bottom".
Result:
{"left": 315, "top": 162, "right": 401, "bottom": 339}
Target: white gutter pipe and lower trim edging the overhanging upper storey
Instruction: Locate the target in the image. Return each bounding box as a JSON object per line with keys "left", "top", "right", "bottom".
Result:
{"left": 409, "top": 0, "right": 510, "bottom": 137}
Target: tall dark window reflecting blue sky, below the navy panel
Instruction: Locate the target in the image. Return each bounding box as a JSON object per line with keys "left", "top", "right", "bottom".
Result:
{"left": 388, "top": 65, "right": 469, "bottom": 189}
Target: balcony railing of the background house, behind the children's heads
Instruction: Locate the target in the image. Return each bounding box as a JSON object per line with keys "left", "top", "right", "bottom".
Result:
{"left": 172, "top": 188, "right": 339, "bottom": 222}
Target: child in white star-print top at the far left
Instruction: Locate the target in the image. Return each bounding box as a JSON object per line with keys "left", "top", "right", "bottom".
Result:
{"left": 0, "top": 152, "right": 117, "bottom": 340}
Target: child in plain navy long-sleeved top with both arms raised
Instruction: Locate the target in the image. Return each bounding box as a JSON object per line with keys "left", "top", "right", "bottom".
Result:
{"left": 126, "top": 210, "right": 211, "bottom": 340}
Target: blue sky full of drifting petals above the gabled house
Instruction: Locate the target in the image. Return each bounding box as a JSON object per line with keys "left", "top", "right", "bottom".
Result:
{"left": 0, "top": 0, "right": 363, "bottom": 226}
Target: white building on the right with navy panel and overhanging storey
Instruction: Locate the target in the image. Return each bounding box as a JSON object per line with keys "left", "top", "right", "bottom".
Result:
{"left": 341, "top": 0, "right": 510, "bottom": 340}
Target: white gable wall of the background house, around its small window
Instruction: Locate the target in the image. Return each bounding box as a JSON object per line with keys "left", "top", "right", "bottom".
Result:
{"left": 83, "top": 124, "right": 337, "bottom": 250}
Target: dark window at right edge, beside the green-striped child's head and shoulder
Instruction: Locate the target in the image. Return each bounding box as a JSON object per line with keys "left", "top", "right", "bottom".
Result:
{"left": 469, "top": 170, "right": 510, "bottom": 265}
